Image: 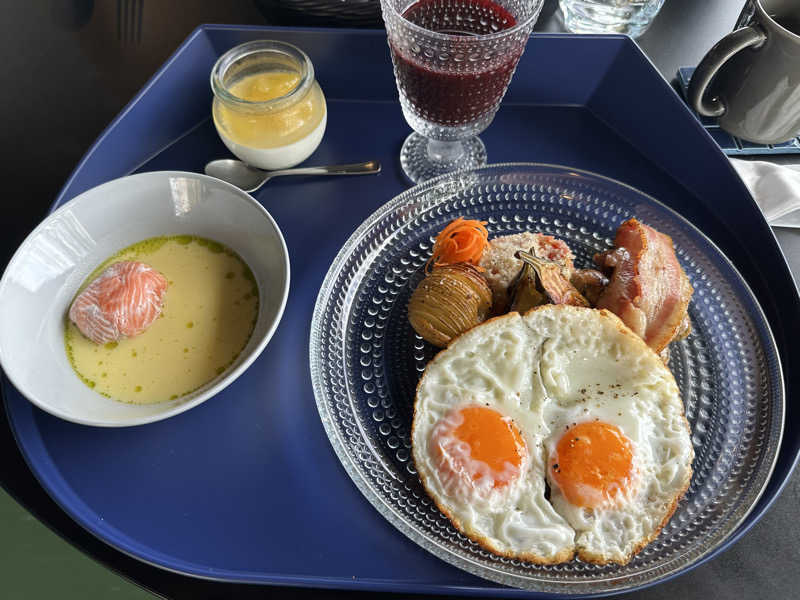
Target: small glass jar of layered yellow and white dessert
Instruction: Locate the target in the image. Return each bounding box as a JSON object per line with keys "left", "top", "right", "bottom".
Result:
{"left": 211, "top": 40, "right": 328, "bottom": 170}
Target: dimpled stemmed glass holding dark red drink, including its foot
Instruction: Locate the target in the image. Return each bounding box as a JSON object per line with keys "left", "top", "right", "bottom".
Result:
{"left": 381, "top": 0, "right": 544, "bottom": 183}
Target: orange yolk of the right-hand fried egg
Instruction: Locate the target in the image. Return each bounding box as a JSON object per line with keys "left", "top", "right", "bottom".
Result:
{"left": 550, "top": 421, "right": 633, "bottom": 508}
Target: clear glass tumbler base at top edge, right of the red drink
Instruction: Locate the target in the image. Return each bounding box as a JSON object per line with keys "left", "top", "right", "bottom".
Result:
{"left": 559, "top": 0, "right": 664, "bottom": 38}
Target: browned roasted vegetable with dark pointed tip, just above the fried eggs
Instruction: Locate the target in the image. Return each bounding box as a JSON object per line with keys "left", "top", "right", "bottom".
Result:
{"left": 509, "top": 250, "right": 589, "bottom": 312}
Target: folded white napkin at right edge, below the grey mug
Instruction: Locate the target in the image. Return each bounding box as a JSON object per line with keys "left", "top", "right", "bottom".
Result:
{"left": 730, "top": 158, "right": 800, "bottom": 227}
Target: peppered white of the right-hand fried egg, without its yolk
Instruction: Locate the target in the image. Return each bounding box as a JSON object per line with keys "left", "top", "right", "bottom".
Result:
{"left": 536, "top": 310, "right": 694, "bottom": 563}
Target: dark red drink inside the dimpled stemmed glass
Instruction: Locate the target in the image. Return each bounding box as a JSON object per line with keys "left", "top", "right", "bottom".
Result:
{"left": 391, "top": 0, "right": 524, "bottom": 126}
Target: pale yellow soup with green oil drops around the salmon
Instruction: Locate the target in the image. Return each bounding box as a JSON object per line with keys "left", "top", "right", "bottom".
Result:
{"left": 65, "top": 236, "right": 259, "bottom": 404}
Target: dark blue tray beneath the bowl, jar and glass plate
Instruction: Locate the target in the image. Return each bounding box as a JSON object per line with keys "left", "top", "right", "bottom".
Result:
{"left": 2, "top": 26, "right": 800, "bottom": 597}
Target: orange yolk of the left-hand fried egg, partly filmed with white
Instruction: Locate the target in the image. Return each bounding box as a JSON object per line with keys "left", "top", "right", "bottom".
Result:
{"left": 436, "top": 406, "right": 527, "bottom": 487}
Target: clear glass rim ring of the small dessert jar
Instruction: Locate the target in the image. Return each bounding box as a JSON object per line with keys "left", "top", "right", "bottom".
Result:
{"left": 211, "top": 40, "right": 314, "bottom": 111}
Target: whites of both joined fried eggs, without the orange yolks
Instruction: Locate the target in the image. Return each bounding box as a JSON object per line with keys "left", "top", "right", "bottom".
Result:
{"left": 412, "top": 305, "right": 693, "bottom": 563}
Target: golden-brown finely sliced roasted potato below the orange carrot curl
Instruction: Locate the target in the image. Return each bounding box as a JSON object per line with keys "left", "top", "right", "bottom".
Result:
{"left": 408, "top": 263, "right": 492, "bottom": 348}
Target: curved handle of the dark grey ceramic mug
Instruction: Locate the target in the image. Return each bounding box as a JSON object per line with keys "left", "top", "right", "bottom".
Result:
{"left": 688, "top": 25, "right": 767, "bottom": 117}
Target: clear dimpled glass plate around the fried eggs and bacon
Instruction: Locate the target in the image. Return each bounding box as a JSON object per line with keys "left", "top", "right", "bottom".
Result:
{"left": 310, "top": 163, "right": 784, "bottom": 595}
